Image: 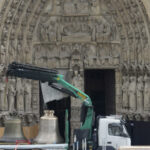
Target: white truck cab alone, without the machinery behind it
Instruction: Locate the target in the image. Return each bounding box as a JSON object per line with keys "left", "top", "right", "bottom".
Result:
{"left": 97, "top": 116, "right": 131, "bottom": 149}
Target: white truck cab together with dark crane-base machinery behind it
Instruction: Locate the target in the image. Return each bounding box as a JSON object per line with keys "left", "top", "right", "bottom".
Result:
{"left": 73, "top": 115, "right": 131, "bottom": 150}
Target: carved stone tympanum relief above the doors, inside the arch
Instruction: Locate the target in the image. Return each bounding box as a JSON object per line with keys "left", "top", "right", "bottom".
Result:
{"left": 34, "top": 0, "right": 120, "bottom": 68}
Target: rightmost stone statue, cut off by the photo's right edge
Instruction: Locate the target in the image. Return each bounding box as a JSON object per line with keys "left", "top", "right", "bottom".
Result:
{"left": 144, "top": 74, "right": 150, "bottom": 111}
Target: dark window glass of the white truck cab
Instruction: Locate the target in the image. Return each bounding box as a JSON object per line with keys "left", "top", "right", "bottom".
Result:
{"left": 108, "top": 123, "right": 129, "bottom": 137}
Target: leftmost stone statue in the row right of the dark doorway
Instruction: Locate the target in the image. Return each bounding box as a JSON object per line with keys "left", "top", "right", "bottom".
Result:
{"left": 122, "top": 76, "right": 129, "bottom": 109}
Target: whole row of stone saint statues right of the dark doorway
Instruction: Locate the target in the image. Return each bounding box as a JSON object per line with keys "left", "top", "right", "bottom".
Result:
{"left": 122, "top": 73, "right": 150, "bottom": 113}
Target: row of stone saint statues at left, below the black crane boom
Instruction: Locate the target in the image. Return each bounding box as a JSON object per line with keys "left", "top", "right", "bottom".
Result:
{"left": 0, "top": 76, "right": 32, "bottom": 112}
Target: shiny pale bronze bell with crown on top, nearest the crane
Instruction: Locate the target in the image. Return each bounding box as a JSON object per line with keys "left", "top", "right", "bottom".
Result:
{"left": 34, "top": 110, "right": 63, "bottom": 144}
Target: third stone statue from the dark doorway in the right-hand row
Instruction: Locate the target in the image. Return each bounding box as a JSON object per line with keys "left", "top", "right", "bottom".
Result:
{"left": 136, "top": 76, "right": 144, "bottom": 113}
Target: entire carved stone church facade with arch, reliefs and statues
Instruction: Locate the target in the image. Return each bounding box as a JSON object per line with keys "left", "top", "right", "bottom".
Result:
{"left": 0, "top": 0, "right": 150, "bottom": 139}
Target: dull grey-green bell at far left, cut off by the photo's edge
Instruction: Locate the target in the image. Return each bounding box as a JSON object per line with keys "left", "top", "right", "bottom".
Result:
{"left": 0, "top": 118, "right": 26, "bottom": 143}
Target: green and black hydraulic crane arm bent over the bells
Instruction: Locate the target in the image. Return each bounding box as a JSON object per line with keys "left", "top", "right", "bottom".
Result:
{"left": 6, "top": 62, "right": 93, "bottom": 137}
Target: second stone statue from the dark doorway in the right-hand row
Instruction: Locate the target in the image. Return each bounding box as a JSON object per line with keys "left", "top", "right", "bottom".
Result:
{"left": 129, "top": 75, "right": 136, "bottom": 111}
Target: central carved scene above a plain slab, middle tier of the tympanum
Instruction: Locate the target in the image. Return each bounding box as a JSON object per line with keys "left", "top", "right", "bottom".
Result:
{"left": 60, "top": 16, "right": 93, "bottom": 42}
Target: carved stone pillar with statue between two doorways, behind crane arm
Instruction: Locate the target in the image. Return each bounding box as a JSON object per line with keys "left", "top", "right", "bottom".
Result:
{"left": 70, "top": 49, "right": 84, "bottom": 142}
